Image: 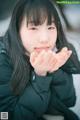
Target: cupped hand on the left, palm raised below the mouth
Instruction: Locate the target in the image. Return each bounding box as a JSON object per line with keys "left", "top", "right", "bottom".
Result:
{"left": 30, "top": 50, "right": 53, "bottom": 76}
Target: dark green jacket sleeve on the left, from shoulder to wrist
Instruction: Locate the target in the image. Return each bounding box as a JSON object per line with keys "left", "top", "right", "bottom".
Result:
{"left": 0, "top": 52, "right": 50, "bottom": 120}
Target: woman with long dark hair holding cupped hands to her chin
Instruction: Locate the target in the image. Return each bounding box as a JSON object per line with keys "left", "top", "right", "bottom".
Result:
{"left": 0, "top": 0, "right": 80, "bottom": 120}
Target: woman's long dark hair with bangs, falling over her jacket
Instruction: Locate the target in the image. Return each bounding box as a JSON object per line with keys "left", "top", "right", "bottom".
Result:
{"left": 4, "top": 0, "right": 79, "bottom": 95}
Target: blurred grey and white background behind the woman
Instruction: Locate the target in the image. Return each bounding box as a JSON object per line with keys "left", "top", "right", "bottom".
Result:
{"left": 0, "top": 0, "right": 80, "bottom": 117}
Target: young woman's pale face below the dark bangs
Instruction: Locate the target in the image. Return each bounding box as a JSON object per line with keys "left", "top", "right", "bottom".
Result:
{"left": 19, "top": 18, "right": 57, "bottom": 54}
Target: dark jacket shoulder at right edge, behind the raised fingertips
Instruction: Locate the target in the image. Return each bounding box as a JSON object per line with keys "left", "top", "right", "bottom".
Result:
{"left": 61, "top": 44, "right": 80, "bottom": 74}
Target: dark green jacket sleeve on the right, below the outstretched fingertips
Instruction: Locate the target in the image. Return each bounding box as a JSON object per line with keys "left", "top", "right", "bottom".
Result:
{"left": 47, "top": 69, "right": 76, "bottom": 107}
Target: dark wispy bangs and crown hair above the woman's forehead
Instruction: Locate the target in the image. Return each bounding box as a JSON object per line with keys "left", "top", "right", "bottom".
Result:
{"left": 24, "top": 0, "right": 55, "bottom": 26}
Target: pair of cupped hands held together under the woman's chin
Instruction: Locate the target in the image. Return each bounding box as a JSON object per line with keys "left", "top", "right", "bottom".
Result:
{"left": 30, "top": 47, "right": 72, "bottom": 76}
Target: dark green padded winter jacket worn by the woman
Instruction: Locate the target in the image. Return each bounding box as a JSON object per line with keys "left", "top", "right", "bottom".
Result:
{"left": 0, "top": 37, "right": 77, "bottom": 120}
